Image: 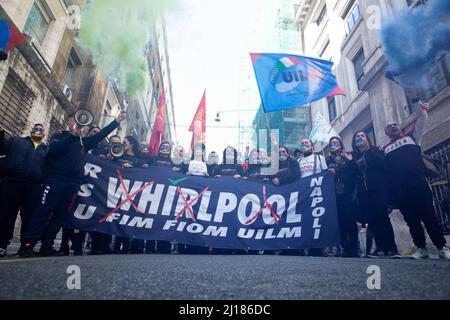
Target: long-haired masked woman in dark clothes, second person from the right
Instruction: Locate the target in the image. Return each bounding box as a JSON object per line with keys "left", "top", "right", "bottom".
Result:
{"left": 352, "top": 131, "right": 399, "bottom": 258}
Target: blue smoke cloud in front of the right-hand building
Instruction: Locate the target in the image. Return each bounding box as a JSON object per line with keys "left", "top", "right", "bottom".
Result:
{"left": 381, "top": 0, "right": 450, "bottom": 88}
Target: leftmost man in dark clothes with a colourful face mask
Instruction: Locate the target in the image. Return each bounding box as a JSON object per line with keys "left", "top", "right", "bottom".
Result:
{"left": 0, "top": 124, "right": 48, "bottom": 257}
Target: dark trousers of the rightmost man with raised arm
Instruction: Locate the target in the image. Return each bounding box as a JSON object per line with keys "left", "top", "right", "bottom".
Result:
{"left": 394, "top": 179, "right": 446, "bottom": 249}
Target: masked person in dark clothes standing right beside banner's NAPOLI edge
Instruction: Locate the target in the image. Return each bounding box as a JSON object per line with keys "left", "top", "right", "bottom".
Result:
{"left": 326, "top": 137, "right": 359, "bottom": 257}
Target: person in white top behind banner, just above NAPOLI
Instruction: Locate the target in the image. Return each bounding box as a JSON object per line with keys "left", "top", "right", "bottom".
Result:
{"left": 298, "top": 138, "right": 328, "bottom": 178}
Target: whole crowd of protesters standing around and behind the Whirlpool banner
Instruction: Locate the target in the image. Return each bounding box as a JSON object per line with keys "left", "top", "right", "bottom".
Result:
{"left": 0, "top": 95, "right": 450, "bottom": 259}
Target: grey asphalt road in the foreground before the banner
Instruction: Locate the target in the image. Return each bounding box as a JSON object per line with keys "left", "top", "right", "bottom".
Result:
{"left": 0, "top": 255, "right": 450, "bottom": 300}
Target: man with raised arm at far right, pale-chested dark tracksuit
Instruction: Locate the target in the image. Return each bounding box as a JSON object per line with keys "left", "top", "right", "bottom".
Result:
{"left": 383, "top": 92, "right": 450, "bottom": 260}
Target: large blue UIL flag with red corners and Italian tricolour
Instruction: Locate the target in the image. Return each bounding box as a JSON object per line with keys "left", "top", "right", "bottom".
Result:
{"left": 250, "top": 53, "right": 345, "bottom": 112}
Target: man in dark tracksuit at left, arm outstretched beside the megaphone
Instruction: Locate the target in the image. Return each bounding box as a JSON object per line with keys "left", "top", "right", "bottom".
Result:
{"left": 19, "top": 112, "right": 125, "bottom": 257}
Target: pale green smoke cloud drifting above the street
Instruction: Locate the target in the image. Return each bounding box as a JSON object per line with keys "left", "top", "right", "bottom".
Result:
{"left": 78, "top": 0, "right": 176, "bottom": 97}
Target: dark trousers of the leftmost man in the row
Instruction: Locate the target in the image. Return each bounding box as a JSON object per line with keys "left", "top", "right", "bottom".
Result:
{"left": 0, "top": 180, "right": 42, "bottom": 248}
